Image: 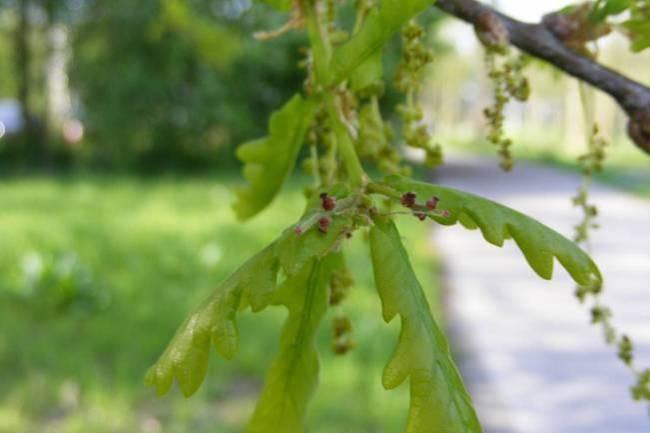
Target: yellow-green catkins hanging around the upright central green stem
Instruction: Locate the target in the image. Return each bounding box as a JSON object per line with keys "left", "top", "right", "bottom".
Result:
{"left": 301, "top": 12, "right": 442, "bottom": 184}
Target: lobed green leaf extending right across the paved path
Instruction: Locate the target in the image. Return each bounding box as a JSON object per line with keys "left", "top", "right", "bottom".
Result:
{"left": 378, "top": 176, "right": 602, "bottom": 286}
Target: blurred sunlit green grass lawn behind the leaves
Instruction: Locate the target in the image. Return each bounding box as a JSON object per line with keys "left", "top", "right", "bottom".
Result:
{"left": 0, "top": 177, "right": 438, "bottom": 433}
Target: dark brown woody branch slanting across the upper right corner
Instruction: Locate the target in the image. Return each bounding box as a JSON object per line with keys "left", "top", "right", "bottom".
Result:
{"left": 435, "top": 0, "right": 650, "bottom": 153}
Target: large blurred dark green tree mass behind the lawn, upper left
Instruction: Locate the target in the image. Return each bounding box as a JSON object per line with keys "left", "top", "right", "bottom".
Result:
{"left": 71, "top": 0, "right": 301, "bottom": 170}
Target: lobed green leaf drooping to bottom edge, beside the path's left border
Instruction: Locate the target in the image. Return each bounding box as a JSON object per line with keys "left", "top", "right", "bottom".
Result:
{"left": 370, "top": 220, "right": 482, "bottom": 433}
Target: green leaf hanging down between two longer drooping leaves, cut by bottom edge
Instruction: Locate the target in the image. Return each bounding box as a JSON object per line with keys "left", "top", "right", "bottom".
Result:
{"left": 249, "top": 258, "right": 331, "bottom": 433}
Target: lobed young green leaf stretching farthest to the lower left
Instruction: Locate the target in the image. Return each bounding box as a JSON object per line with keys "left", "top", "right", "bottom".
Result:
{"left": 145, "top": 199, "right": 351, "bottom": 396}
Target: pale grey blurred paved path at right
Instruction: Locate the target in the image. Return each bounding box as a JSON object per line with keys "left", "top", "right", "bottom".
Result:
{"left": 435, "top": 160, "right": 650, "bottom": 433}
